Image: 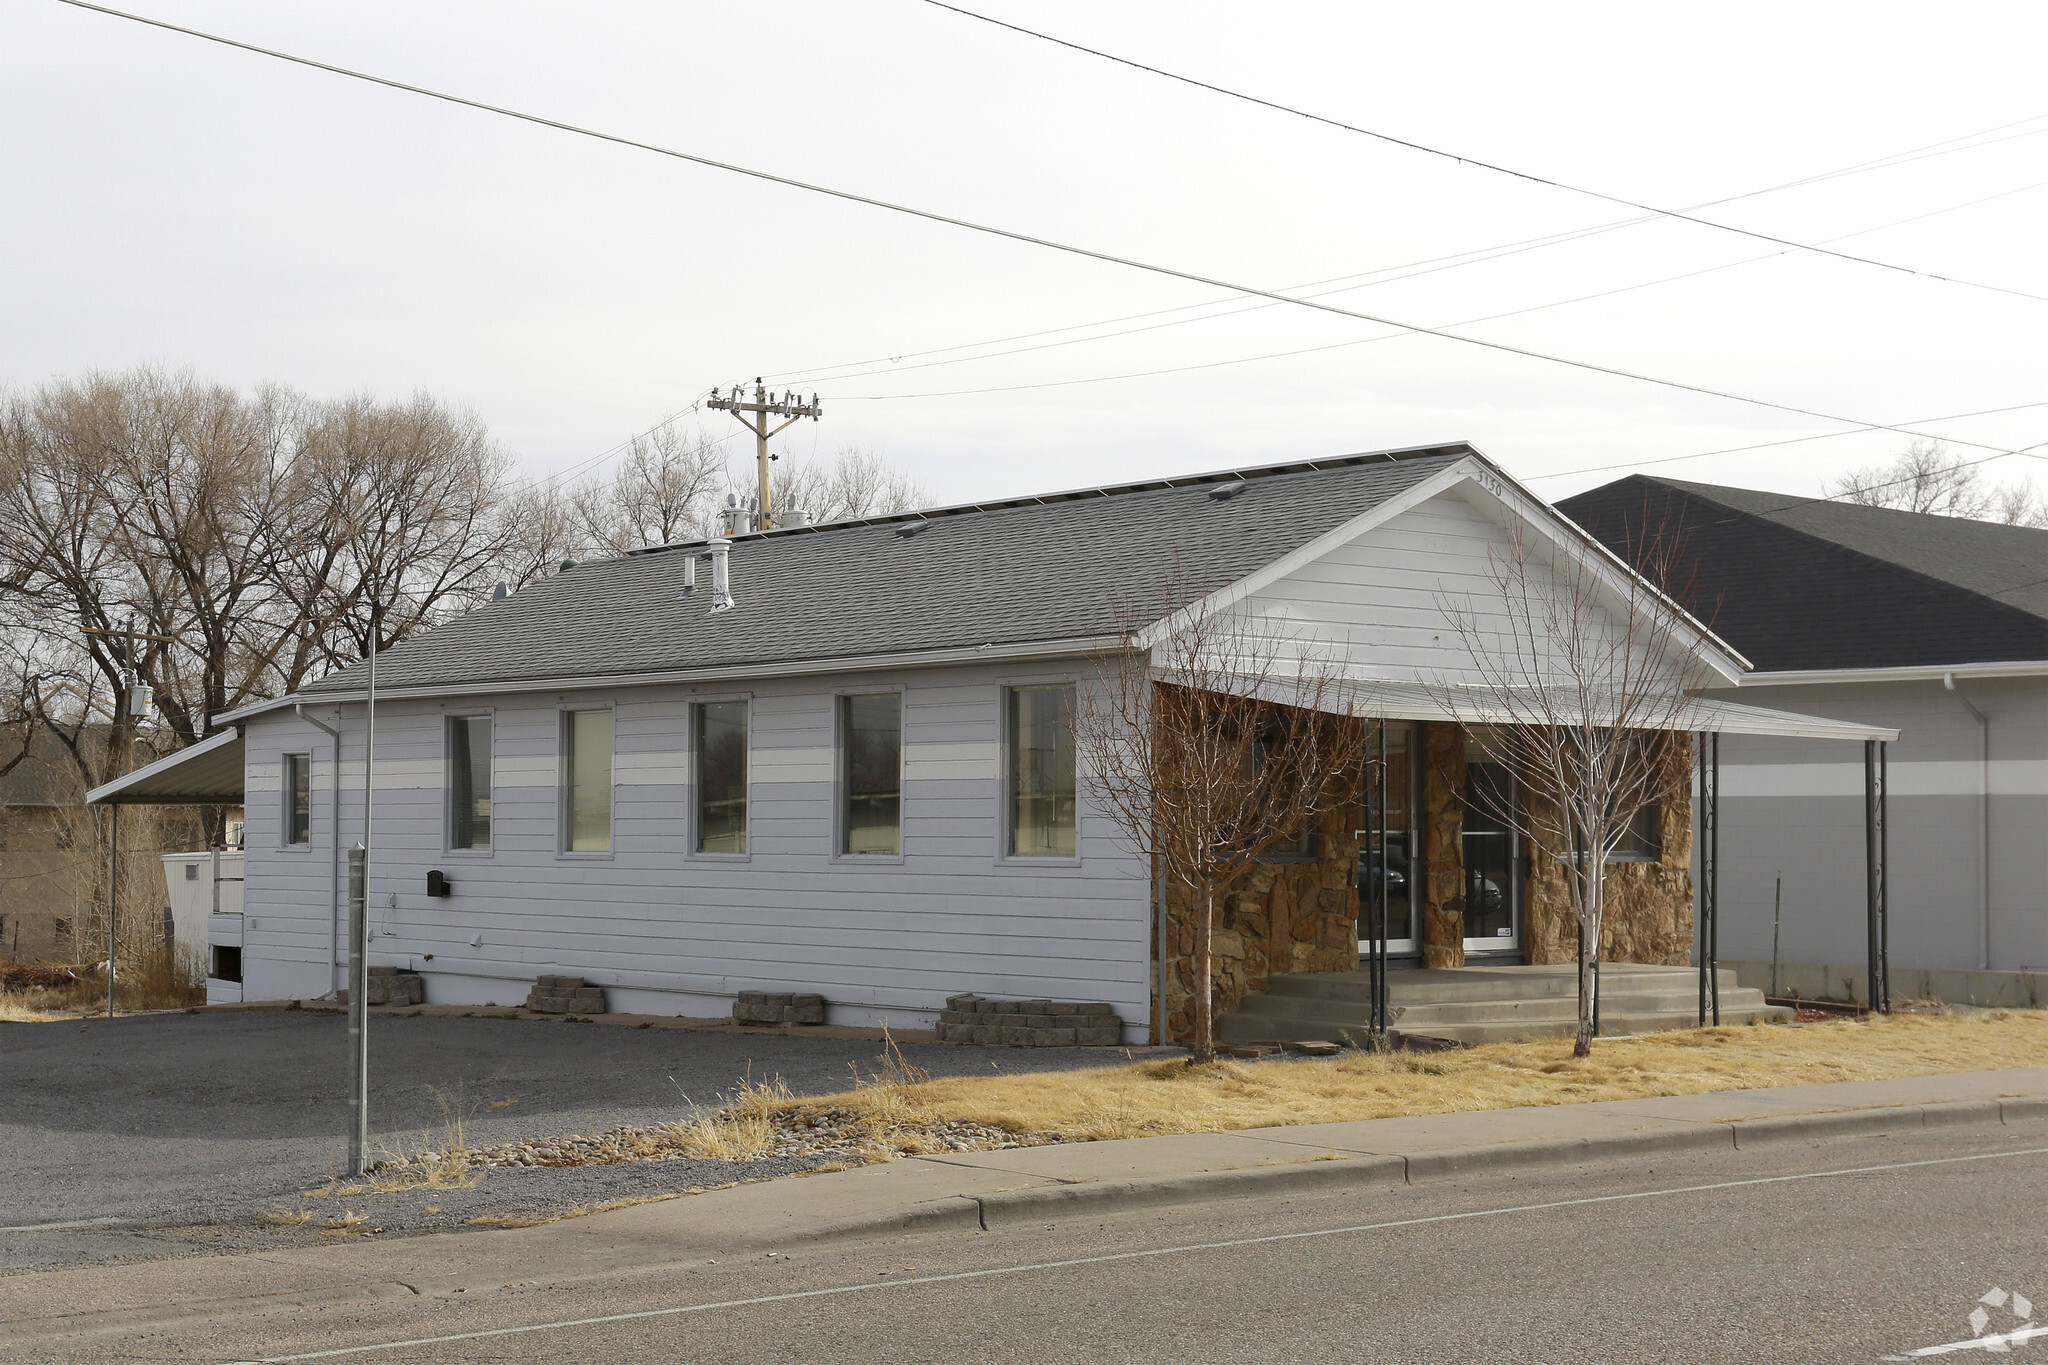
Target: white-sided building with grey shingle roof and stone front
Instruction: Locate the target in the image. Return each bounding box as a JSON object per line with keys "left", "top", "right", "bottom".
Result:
{"left": 94, "top": 444, "right": 1864, "bottom": 1042}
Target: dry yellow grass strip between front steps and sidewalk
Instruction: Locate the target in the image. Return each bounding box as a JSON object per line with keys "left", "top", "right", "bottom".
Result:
{"left": 784, "top": 1011, "right": 2048, "bottom": 1150}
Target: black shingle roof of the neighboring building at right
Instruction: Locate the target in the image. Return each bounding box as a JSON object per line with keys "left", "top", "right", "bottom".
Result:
{"left": 1559, "top": 475, "right": 2048, "bottom": 671}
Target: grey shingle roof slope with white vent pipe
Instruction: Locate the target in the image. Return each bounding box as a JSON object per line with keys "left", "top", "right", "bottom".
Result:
{"left": 303, "top": 444, "right": 1475, "bottom": 696}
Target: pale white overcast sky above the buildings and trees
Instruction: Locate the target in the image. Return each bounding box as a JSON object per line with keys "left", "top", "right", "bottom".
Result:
{"left": 0, "top": 0, "right": 2048, "bottom": 511}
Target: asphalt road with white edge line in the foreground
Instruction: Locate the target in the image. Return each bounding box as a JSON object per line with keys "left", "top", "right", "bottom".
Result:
{"left": 28, "top": 1124, "right": 2048, "bottom": 1365}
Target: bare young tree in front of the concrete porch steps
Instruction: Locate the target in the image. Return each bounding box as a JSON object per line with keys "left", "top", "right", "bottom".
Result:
{"left": 1432, "top": 530, "right": 1708, "bottom": 1056}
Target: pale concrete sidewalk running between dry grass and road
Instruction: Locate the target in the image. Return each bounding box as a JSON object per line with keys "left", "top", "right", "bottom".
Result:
{"left": 0, "top": 1068, "right": 2048, "bottom": 1342}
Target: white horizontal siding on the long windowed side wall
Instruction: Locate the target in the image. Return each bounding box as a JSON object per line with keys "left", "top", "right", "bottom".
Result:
{"left": 248, "top": 665, "right": 1151, "bottom": 1025}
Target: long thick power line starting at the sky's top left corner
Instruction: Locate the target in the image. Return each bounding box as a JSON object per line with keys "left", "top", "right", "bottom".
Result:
{"left": 59, "top": 0, "right": 2048, "bottom": 474}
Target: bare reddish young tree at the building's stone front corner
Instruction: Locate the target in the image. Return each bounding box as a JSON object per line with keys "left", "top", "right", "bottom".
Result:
{"left": 1075, "top": 579, "right": 1364, "bottom": 1062}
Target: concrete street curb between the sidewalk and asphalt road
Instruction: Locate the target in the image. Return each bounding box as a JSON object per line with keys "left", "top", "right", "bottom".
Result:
{"left": 0, "top": 1095, "right": 2048, "bottom": 1345}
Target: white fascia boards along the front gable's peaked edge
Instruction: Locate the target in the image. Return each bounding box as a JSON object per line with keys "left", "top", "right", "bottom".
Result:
{"left": 1137, "top": 452, "right": 1751, "bottom": 684}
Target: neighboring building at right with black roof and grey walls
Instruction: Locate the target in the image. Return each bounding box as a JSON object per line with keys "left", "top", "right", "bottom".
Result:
{"left": 1559, "top": 475, "right": 2048, "bottom": 999}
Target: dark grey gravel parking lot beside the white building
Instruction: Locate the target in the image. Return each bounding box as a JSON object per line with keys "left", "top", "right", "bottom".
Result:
{"left": 0, "top": 1011, "right": 1155, "bottom": 1273}
